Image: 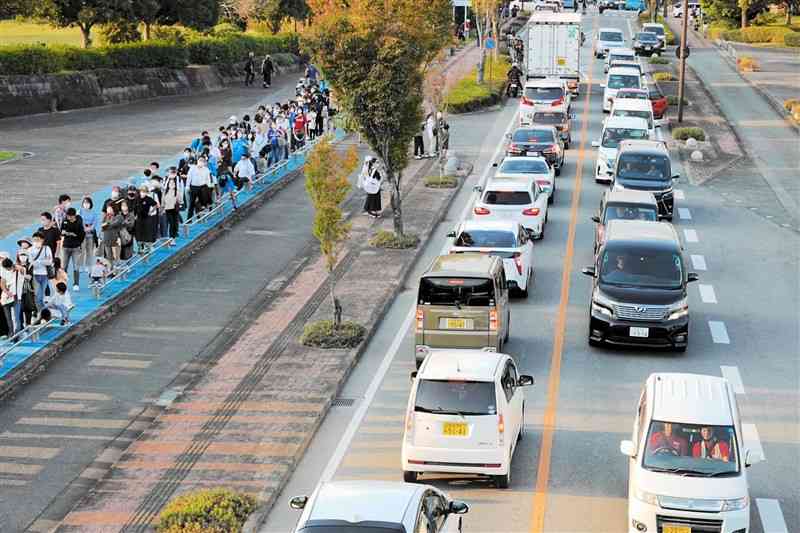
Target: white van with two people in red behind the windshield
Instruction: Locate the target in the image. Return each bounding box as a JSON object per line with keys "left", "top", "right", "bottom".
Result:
{"left": 620, "top": 373, "right": 762, "bottom": 533}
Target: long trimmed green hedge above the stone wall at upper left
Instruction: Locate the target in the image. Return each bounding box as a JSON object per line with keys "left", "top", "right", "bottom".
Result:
{"left": 0, "top": 33, "right": 299, "bottom": 75}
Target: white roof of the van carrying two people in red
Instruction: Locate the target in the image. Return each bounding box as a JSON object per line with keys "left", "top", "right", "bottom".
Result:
{"left": 647, "top": 373, "right": 733, "bottom": 426}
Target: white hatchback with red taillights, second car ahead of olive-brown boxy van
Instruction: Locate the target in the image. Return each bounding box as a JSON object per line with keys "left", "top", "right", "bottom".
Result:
{"left": 472, "top": 178, "right": 549, "bottom": 239}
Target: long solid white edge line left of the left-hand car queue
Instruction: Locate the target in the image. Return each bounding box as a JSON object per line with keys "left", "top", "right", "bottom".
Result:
{"left": 317, "top": 104, "right": 518, "bottom": 488}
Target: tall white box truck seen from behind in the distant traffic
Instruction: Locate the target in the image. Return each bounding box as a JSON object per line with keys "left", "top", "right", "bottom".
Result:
{"left": 525, "top": 12, "right": 582, "bottom": 94}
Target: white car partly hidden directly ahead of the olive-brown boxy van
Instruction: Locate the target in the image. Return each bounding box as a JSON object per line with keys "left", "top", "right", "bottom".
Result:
{"left": 447, "top": 220, "right": 533, "bottom": 298}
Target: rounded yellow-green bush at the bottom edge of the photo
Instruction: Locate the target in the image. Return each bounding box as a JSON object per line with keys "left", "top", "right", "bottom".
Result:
{"left": 156, "top": 488, "right": 256, "bottom": 533}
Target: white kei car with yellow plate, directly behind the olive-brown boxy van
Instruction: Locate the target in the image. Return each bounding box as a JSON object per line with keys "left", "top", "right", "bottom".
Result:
{"left": 402, "top": 350, "right": 533, "bottom": 488}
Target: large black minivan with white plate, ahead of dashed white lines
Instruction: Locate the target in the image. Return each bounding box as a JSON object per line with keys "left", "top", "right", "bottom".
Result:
{"left": 583, "top": 220, "right": 697, "bottom": 352}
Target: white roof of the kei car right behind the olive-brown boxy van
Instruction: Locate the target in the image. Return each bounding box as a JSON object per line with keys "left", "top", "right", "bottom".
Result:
{"left": 417, "top": 350, "right": 508, "bottom": 381}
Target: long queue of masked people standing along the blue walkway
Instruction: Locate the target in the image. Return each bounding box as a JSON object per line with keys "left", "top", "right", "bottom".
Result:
{"left": 0, "top": 64, "right": 335, "bottom": 340}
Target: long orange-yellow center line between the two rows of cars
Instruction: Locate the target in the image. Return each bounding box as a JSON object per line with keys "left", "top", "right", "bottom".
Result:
{"left": 530, "top": 52, "right": 592, "bottom": 533}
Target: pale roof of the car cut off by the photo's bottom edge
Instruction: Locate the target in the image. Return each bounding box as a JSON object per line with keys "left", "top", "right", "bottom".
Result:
{"left": 308, "top": 480, "right": 426, "bottom": 524}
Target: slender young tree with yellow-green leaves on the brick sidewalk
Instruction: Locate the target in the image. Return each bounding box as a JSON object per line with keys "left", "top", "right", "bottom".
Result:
{"left": 304, "top": 136, "right": 358, "bottom": 328}
